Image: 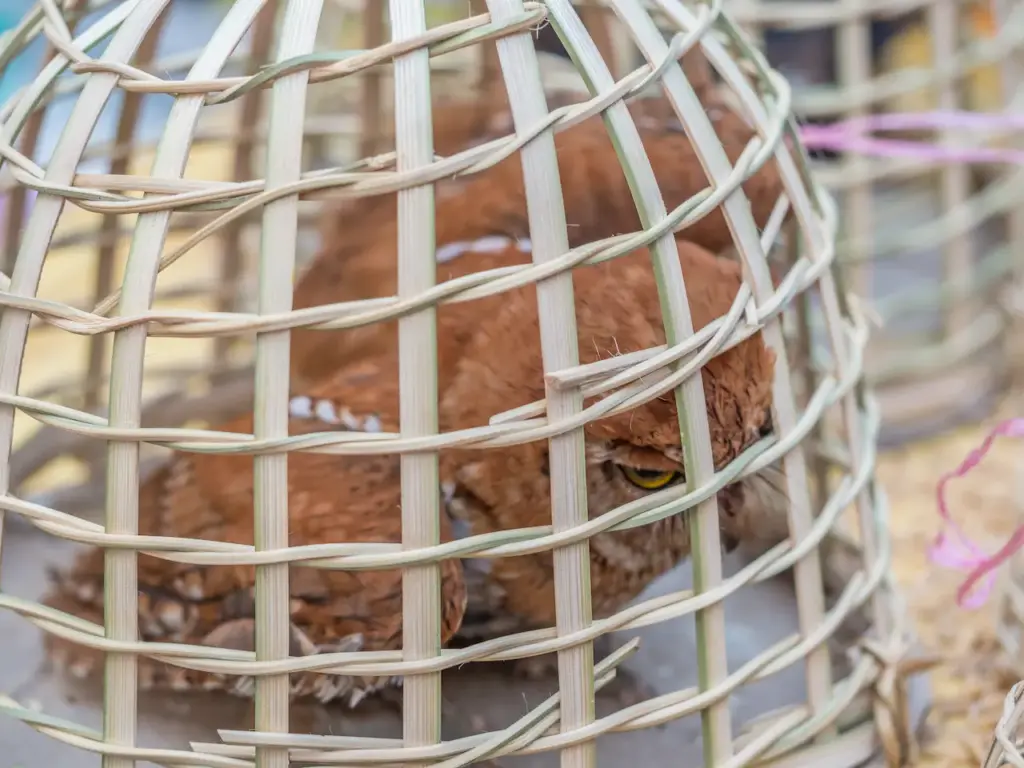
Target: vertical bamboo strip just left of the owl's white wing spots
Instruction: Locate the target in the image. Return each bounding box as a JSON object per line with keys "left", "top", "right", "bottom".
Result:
{"left": 253, "top": 0, "right": 323, "bottom": 768}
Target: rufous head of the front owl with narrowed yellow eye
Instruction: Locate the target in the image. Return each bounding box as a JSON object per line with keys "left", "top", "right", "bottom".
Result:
{"left": 441, "top": 242, "right": 784, "bottom": 606}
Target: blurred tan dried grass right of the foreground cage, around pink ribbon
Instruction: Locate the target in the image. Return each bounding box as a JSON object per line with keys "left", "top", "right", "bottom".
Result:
{"left": 878, "top": 396, "right": 1024, "bottom": 768}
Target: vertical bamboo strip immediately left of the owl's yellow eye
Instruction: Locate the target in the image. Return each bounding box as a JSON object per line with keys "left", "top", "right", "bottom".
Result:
{"left": 487, "top": 0, "right": 597, "bottom": 768}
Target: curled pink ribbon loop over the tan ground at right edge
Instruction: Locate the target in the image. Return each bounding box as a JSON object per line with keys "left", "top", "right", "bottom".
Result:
{"left": 929, "top": 419, "right": 1024, "bottom": 608}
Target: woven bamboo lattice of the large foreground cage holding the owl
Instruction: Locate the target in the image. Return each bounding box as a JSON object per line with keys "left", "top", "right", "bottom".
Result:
{"left": 0, "top": 0, "right": 917, "bottom": 768}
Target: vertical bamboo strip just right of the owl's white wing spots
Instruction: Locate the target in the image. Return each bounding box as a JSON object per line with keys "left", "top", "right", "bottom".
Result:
{"left": 388, "top": 0, "right": 441, "bottom": 746}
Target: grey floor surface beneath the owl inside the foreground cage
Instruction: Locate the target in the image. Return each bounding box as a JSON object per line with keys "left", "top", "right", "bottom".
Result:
{"left": 0, "top": 523, "right": 929, "bottom": 768}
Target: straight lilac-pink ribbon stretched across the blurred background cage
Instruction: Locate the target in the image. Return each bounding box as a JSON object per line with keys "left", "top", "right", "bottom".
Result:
{"left": 800, "top": 111, "right": 1024, "bottom": 165}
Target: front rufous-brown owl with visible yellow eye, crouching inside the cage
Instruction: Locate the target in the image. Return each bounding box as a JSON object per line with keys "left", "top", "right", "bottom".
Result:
{"left": 37, "top": 238, "right": 784, "bottom": 705}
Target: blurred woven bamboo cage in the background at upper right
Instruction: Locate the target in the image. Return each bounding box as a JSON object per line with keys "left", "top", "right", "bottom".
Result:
{"left": 696, "top": 0, "right": 1024, "bottom": 442}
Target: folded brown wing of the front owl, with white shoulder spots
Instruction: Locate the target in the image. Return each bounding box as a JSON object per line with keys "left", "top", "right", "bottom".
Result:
{"left": 44, "top": 365, "right": 466, "bottom": 703}
